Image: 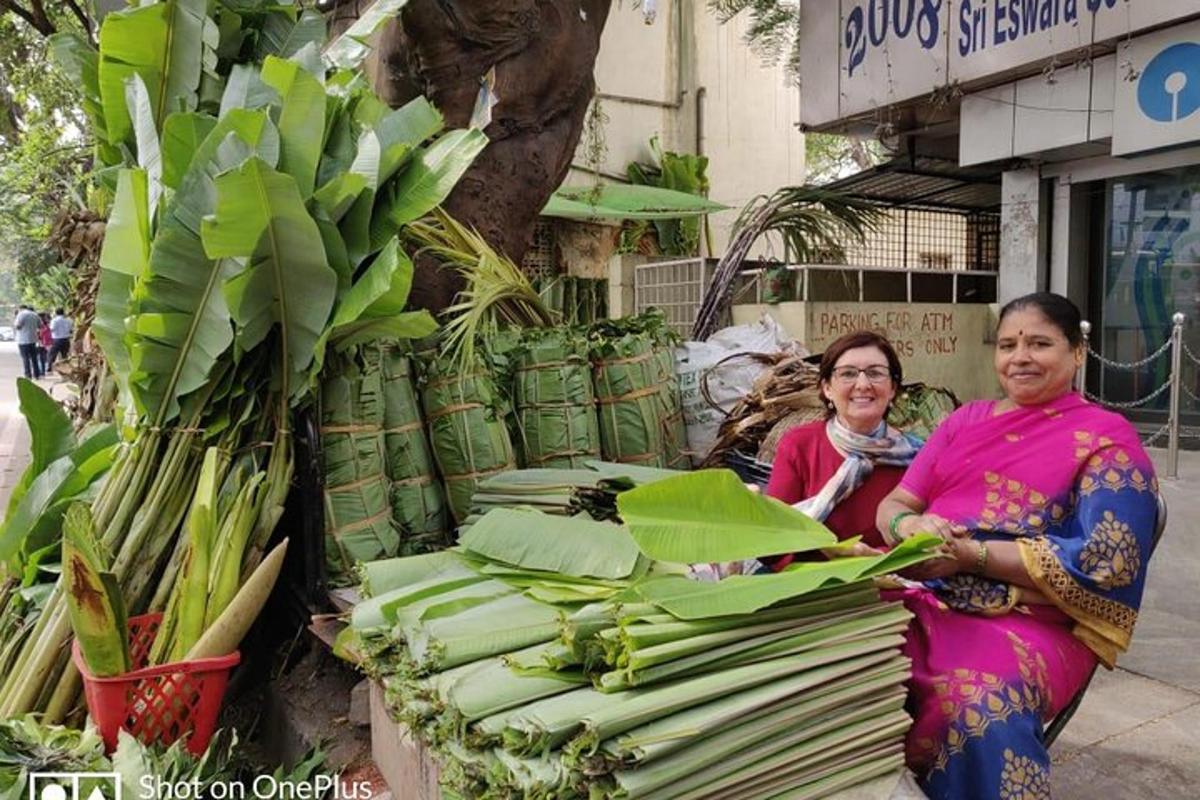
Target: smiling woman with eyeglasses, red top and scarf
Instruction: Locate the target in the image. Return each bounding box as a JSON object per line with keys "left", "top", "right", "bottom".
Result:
{"left": 767, "top": 331, "right": 919, "bottom": 570}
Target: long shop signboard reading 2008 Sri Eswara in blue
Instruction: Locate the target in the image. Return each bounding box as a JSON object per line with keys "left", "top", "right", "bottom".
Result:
{"left": 800, "top": 0, "right": 1200, "bottom": 125}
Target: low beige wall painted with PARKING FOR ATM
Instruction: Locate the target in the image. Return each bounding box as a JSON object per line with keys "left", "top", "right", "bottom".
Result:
{"left": 733, "top": 302, "right": 1000, "bottom": 402}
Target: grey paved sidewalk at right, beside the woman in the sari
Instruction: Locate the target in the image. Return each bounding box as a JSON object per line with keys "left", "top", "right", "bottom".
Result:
{"left": 1050, "top": 450, "right": 1200, "bottom": 800}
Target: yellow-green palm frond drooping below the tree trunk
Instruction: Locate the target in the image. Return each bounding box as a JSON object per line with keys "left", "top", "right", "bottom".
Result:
{"left": 406, "top": 209, "right": 557, "bottom": 367}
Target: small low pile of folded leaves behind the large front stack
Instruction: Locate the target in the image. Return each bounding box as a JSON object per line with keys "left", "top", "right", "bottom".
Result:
{"left": 463, "top": 462, "right": 679, "bottom": 527}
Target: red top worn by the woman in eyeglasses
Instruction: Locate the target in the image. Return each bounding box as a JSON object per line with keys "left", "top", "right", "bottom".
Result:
{"left": 767, "top": 420, "right": 904, "bottom": 551}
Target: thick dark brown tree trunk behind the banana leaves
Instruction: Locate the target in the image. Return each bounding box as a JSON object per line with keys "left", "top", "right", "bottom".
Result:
{"left": 378, "top": 0, "right": 612, "bottom": 311}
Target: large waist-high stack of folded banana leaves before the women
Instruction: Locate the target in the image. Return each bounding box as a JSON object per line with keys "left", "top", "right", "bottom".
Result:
{"left": 346, "top": 470, "right": 936, "bottom": 800}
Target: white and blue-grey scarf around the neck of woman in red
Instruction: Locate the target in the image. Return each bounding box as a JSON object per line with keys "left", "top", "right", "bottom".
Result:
{"left": 792, "top": 416, "right": 922, "bottom": 522}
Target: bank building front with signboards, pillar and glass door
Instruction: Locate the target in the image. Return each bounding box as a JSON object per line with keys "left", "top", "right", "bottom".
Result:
{"left": 800, "top": 0, "right": 1200, "bottom": 416}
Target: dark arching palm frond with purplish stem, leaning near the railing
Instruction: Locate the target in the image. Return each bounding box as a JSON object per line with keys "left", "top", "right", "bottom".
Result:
{"left": 691, "top": 186, "right": 887, "bottom": 339}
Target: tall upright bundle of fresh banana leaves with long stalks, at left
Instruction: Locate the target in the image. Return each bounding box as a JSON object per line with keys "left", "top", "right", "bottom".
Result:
{"left": 0, "top": 0, "right": 486, "bottom": 722}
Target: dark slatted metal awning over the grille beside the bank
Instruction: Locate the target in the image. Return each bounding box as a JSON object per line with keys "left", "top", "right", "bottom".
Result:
{"left": 824, "top": 156, "right": 1000, "bottom": 212}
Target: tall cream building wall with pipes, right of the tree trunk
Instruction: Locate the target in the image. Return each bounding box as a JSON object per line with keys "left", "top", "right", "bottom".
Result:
{"left": 568, "top": 0, "right": 804, "bottom": 255}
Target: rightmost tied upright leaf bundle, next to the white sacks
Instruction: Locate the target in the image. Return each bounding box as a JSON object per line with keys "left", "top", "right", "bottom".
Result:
{"left": 590, "top": 311, "right": 690, "bottom": 469}
